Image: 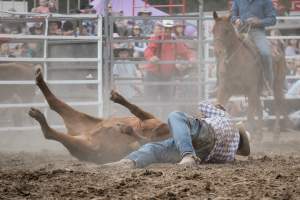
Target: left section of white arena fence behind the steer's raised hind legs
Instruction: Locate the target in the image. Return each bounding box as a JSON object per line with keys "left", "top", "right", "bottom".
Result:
{"left": 0, "top": 12, "right": 103, "bottom": 131}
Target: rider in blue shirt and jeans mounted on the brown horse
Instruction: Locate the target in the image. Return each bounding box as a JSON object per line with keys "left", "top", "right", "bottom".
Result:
{"left": 231, "top": 0, "right": 276, "bottom": 89}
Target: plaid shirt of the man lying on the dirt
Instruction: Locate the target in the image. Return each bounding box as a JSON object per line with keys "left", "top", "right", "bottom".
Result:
{"left": 198, "top": 102, "right": 240, "bottom": 163}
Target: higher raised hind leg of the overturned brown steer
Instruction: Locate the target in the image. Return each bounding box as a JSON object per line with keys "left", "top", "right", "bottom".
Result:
{"left": 35, "top": 68, "right": 101, "bottom": 135}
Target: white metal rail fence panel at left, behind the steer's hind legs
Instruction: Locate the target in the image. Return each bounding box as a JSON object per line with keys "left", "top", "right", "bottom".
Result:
{"left": 0, "top": 11, "right": 103, "bottom": 132}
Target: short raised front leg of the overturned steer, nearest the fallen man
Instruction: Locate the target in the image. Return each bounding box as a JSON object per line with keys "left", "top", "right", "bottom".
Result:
{"left": 110, "top": 90, "right": 155, "bottom": 120}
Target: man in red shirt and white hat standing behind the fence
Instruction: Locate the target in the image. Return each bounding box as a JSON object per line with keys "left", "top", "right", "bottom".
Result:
{"left": 144, "top": 20, "right": 195, "bottom": 119}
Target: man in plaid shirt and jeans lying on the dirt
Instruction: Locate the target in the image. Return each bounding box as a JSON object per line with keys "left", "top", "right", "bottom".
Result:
{"left": 105, "top": 103, "right": 250, "bottom": 168}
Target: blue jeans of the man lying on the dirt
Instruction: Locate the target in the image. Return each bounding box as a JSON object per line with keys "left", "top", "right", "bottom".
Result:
{"left": 126, "top": 112, "right": 213, "bottom": 167}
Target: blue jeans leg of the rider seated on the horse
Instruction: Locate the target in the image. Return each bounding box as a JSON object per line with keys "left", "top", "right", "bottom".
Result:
{"left": 249, "top": 29, "right": 274, "bottom": 88}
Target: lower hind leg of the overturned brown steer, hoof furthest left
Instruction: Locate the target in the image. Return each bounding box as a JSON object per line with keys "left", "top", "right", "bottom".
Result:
{"left": 28, "top": 108, "right": 92, "bottom": 159}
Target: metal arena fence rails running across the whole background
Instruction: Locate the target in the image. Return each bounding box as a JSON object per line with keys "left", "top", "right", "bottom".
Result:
{"left": 0, "top": 12, "right": 300, "bottom": 132}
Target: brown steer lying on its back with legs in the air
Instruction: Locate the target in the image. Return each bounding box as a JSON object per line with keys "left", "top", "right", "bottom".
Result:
{"left": 29, "top": 69, "right": 169, "bottom": 163}
